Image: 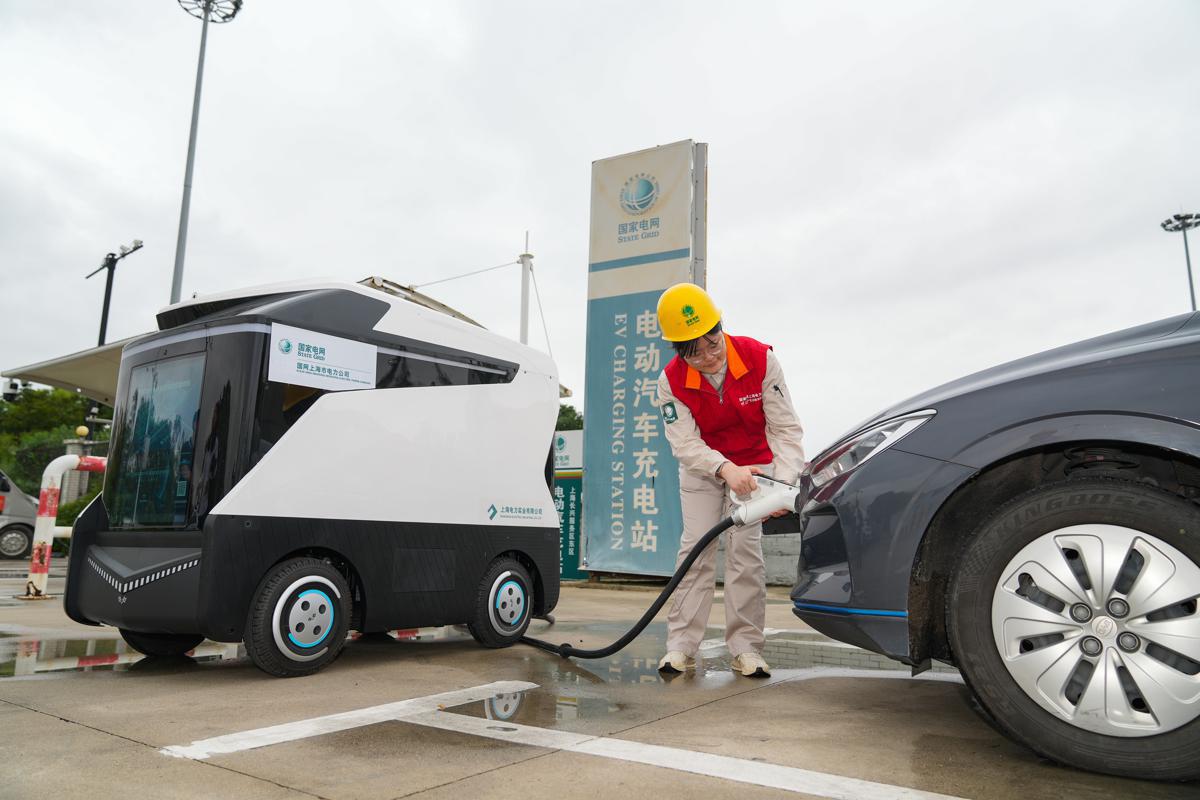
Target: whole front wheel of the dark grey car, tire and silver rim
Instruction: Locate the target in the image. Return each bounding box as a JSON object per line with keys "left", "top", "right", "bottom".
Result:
{"left": 947, "top": 477, "right": 1200, "bottom": 781}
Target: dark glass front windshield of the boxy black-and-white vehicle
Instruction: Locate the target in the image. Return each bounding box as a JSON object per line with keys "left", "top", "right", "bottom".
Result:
{"left": 104, "top": 353, "right": 204, "bottom": 528}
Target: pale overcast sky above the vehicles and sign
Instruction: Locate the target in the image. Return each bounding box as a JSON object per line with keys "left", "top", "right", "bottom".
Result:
{"left": 0, "top": 0, "right": 1200, "bottom": 456}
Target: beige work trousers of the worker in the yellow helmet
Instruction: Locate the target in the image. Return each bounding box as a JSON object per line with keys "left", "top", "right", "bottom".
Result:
{"left": 667, "top": 464, "right": 770, "bottom": 656}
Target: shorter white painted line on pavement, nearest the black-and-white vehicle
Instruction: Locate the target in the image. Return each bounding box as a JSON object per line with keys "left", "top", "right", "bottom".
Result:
{"left": 158, "top": 680, "right": 538, "bottom": 760}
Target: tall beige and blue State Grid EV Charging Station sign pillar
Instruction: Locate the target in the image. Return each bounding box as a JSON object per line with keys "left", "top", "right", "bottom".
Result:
{"left": 583, "top": 140, "right": 708, "bottom": 575}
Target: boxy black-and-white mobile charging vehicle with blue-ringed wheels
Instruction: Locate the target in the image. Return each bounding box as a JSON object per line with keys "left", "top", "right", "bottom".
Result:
{"left": 65, "top": 278, "right": 559, "bottom": 676}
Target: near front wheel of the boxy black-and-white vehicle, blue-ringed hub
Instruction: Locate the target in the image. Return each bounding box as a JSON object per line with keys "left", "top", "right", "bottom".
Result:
{"left": 245, "top": 558, "right": 353, "bottom": 678}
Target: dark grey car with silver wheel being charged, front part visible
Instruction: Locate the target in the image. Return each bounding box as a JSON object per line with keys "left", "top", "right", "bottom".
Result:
{"left": 792, "top": 314, "right": 1200, "bottom": 780}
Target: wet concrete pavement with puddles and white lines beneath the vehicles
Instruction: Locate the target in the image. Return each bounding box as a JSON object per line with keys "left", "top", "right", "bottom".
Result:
{"left": 0, "top": 579, "right": 1200, "bottom": 800}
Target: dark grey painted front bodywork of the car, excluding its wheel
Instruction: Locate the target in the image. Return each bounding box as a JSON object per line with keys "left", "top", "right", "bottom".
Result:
{"left": 792, "top": 314, "right": 1200, "bottom": 661}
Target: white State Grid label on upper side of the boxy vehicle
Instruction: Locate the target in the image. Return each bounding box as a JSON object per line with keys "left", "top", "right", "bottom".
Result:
{"left": 266, "top": 323, "right": 376, "bottom": 392}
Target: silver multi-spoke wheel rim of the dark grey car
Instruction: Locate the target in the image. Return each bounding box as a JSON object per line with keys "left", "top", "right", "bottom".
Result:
{"left": 991, "top": 524, "right": 1200, "bottom": 738}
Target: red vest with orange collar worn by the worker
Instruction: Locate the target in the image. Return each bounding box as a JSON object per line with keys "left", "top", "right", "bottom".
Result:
{"left": 664, "top": 333, "right": 774, "bottom": 467}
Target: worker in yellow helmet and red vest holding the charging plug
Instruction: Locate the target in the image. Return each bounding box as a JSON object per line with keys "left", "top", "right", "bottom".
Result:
{"left": 658, "top": 283, "right": 804, "bottom": 676}
